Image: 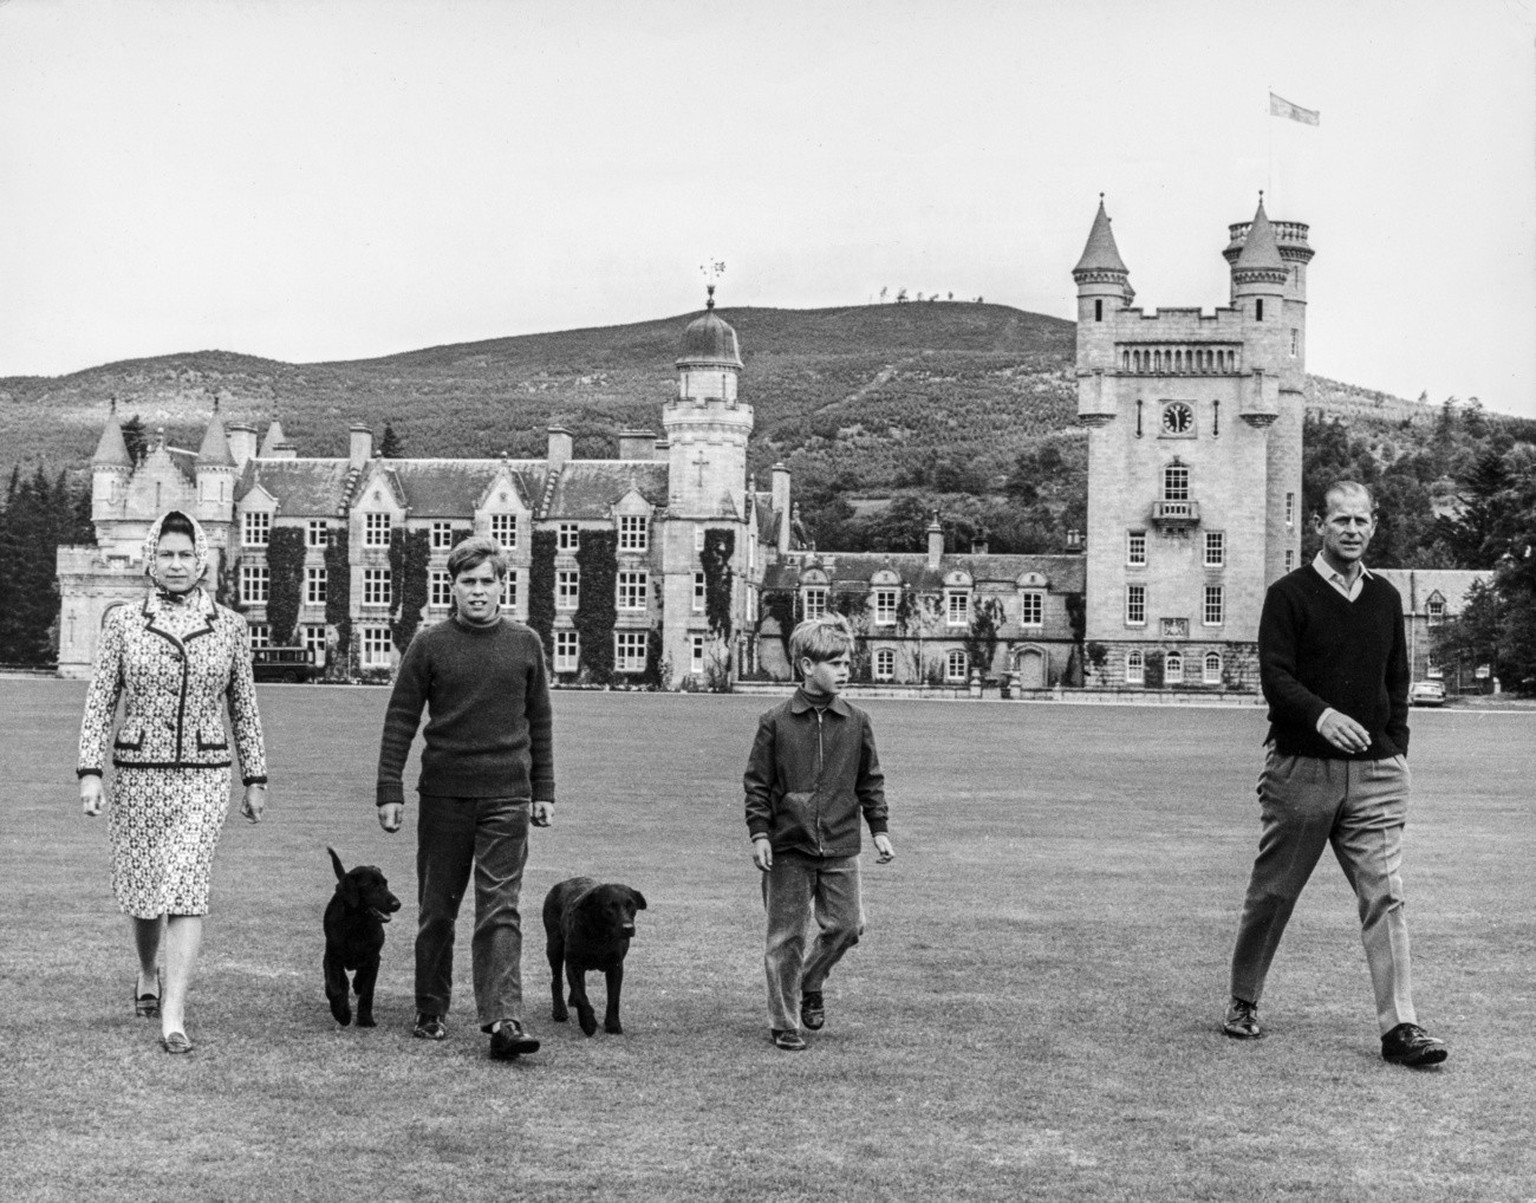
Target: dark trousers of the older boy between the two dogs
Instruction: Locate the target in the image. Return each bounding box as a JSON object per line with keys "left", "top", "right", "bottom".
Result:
{"left": 416, "top": 794, "right": 530, "bottom": 1029}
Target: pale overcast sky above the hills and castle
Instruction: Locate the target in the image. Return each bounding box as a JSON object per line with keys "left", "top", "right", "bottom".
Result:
{"left": 0, "top": 0, "right": 1536, "bottom": 416}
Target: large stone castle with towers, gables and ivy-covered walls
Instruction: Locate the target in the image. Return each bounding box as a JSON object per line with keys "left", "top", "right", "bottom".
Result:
{"left": 58, "top": 198, "right": 1312, "bottom": 691}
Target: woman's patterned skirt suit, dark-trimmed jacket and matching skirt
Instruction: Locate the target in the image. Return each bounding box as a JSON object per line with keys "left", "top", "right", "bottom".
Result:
{"left": 78, "top": 588, "right": 266, "bottom": 919}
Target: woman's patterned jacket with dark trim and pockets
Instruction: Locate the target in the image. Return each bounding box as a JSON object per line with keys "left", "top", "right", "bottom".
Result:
{"left": 77, "top": 590, "right": 267, "bottom": 785}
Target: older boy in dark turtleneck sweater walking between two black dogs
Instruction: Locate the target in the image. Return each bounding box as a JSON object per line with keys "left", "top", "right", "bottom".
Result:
{"left": 378, "top": 538, "right": 554, "bottom": 1060}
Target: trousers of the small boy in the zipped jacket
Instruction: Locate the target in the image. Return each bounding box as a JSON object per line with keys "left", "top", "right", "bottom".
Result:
{"left": 762, "top": 853, "right": 865, "bottom": 1031}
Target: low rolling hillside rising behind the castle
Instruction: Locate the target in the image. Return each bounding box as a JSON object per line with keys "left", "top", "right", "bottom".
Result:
{"left": 0, "top": 303, "right": 1433, "bottom": 493}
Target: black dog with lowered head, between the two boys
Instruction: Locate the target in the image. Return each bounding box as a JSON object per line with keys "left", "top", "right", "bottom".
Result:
{"left": 544, "top": 877, "right": 645, "bottom": 1036}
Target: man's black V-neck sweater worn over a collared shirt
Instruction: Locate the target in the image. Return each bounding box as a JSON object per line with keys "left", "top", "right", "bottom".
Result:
{"left": 1258, "top": 564, "right": 1409, "bottom": 761}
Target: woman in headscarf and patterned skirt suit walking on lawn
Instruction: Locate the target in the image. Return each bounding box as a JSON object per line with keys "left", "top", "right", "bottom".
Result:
{"left": 77, "top": 510, "right": 267, "bottom": 1052}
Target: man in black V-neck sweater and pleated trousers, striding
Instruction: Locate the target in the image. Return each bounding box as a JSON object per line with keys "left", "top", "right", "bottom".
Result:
{"left": 1223, "top": 481, "right": 1447, "bottom": 1066}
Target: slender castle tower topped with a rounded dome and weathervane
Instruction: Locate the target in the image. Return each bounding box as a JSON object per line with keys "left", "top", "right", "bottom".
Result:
{"left": 662, "top": 284, "right": 753, "bottom": 684}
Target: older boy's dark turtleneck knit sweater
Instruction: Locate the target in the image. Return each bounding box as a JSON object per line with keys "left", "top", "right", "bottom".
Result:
{"left": 378, "top": 618, "right": 554, "bottom": 807}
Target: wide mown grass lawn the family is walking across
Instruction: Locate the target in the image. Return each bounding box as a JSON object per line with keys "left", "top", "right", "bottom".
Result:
{"left": 0, "top": 679, "right": 1536, "bottom": 1201}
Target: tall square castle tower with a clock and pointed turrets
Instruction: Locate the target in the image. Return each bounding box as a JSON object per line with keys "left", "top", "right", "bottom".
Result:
{"left": 1072, "top": 200, "right": 1312, "bottom": 690}
